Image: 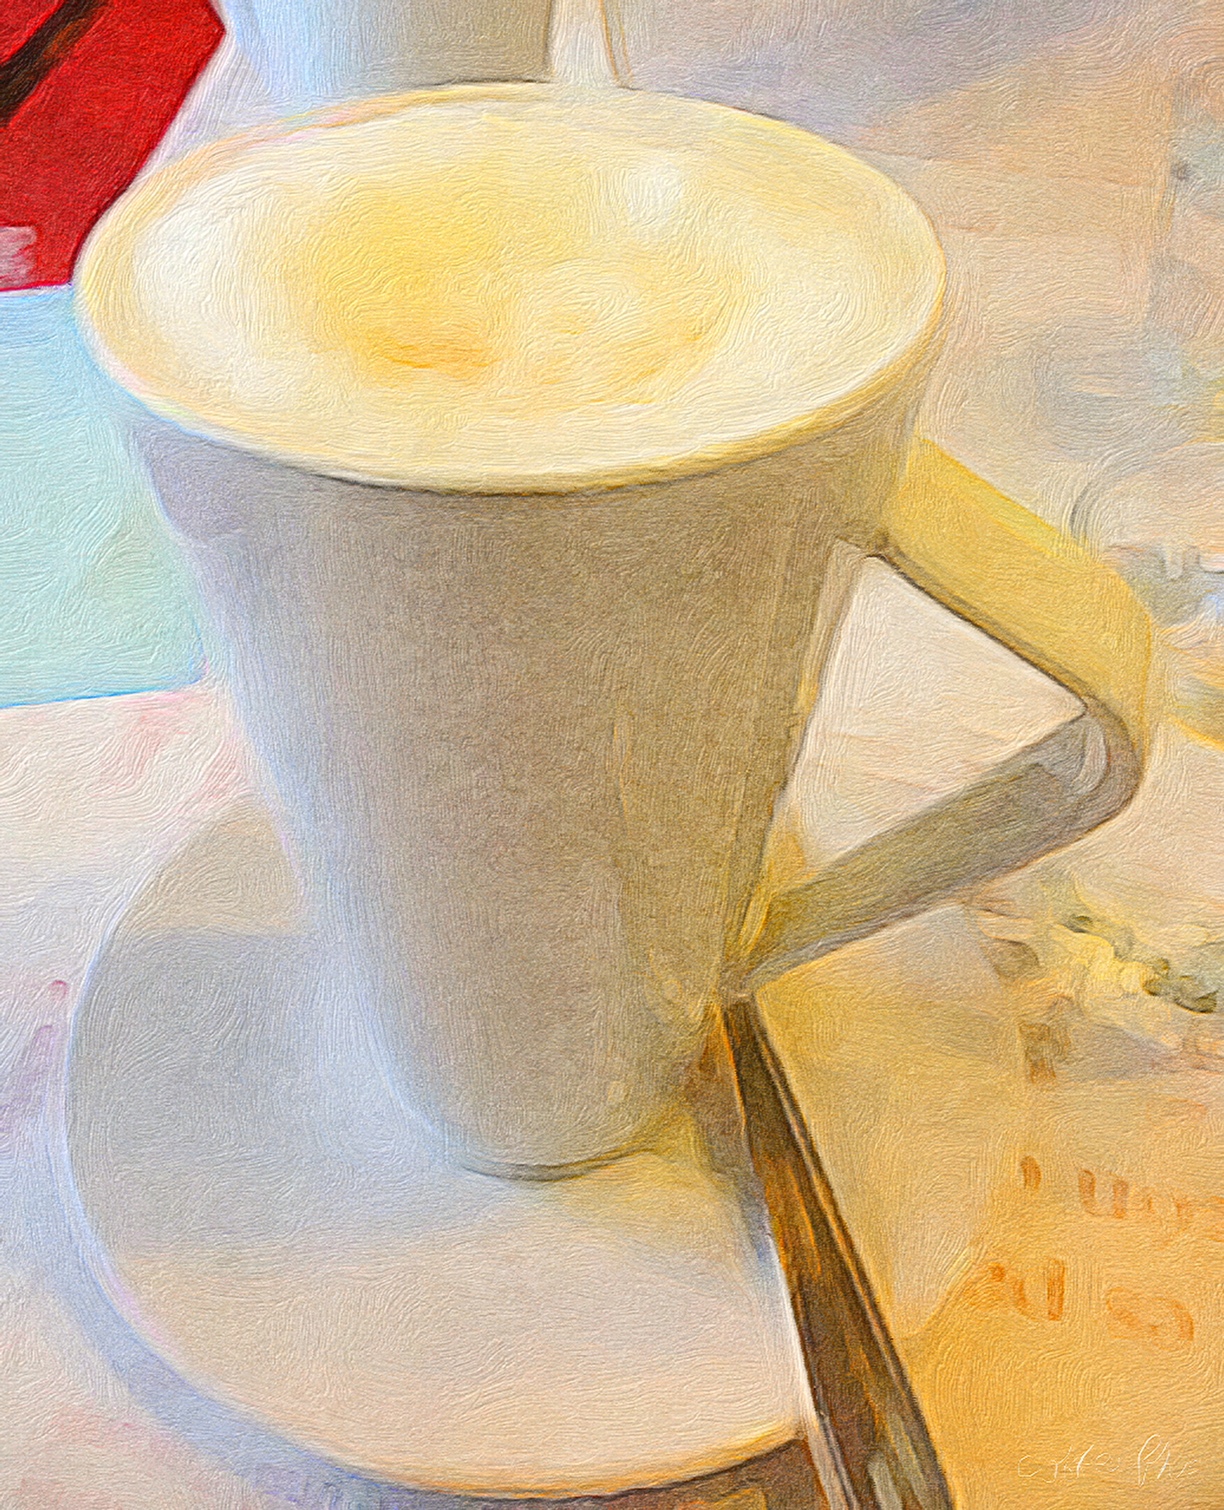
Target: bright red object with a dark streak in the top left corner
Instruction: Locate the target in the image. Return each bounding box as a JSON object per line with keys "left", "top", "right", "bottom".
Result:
{"left": 0, "top": 0, "right": 222, "bottom": 288}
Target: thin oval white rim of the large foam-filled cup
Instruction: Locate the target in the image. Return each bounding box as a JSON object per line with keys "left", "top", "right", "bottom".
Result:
{"left": 72, "top": 83, "right": 946, "bottom": 498}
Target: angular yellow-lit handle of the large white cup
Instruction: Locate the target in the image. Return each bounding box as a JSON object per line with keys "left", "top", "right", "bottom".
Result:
{"left": 724, "top": 441, "right": 1150, "bottom": 1000}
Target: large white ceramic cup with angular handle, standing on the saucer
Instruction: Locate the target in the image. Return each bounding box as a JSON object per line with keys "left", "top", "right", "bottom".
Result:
{"left": 78, "top": 86, "right": 1146, "bottom": 1175}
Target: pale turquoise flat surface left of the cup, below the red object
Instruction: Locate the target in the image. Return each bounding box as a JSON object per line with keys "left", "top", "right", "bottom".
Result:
{"left": 0, "top": 288, "right": 204, "bottom": 707}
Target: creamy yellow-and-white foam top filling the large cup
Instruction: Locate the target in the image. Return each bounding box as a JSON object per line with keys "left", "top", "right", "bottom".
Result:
{"left": 77, "top": 85, "right": 943, "bottom": 492}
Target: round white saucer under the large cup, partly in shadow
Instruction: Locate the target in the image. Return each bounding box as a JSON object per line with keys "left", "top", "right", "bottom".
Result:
{"left": 68, "top": 806, "right": 806, "bottom": 1495}
